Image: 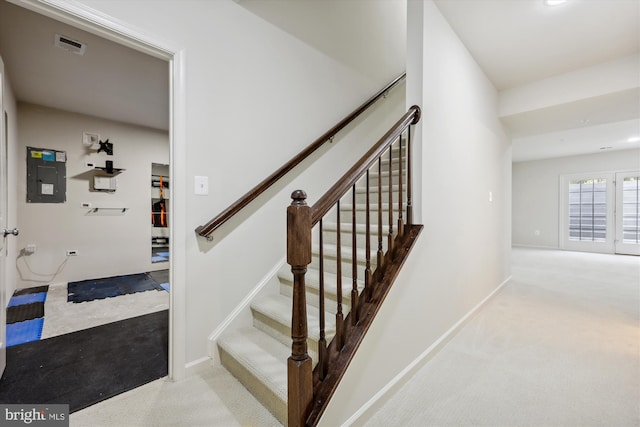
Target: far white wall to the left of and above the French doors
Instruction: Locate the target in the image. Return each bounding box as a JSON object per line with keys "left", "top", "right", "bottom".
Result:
{"left": 512, "top": 150, "right": 640, "bottom": 248}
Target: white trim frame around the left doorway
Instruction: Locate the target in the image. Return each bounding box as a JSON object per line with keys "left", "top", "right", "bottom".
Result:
{"left": 8, "top": 0, "right": 187, "bottom": 380}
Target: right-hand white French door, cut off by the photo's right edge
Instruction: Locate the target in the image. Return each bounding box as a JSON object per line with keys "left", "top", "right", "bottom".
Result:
{"left": 615, "top": 171, "right": 640, "bottom": 255}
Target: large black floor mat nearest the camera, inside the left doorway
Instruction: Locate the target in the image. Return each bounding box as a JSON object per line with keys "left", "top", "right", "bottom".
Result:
{"left": 0, "top": 310, "right": 169, "bottom": 412}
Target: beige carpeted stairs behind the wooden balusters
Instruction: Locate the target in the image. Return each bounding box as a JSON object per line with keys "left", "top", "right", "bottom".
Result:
{"left": 217, "top": 147, "right": 406, "bottom": 425}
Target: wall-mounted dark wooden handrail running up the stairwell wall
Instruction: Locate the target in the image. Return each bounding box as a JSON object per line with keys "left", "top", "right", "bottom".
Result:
{"left": 195, "top": 73, "right": 406, "bottom": 240}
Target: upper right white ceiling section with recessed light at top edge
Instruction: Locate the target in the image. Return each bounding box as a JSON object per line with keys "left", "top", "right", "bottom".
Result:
{"left": 435, "top": 0, "right": 640, "bottom": 90}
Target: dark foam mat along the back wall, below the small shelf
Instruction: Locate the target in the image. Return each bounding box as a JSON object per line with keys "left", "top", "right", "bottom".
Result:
{"left": 67, "top": 273, "right": 163, "bottom": 303}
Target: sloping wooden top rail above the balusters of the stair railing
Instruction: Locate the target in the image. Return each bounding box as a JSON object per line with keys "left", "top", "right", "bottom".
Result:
{"left": 311, "top": 105, "right": 420, "bottom": 225}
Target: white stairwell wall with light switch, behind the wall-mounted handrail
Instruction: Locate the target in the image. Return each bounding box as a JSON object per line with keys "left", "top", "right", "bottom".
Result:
{"left": 61, "top": 0, "right": 404, "bottom": 363}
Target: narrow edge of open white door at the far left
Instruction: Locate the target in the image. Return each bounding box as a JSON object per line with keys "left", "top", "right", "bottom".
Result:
{"left": 0, "top": 58, "right": 8, "bottom": 376}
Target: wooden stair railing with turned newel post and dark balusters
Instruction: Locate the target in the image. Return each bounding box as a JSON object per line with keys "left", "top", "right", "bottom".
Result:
{"left": 287, "top": 106, "right": 421, "bottom": 427}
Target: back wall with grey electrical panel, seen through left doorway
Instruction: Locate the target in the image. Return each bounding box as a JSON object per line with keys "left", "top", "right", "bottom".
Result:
{"left": 16, "top": 103, "right": 169, "bottom": 288}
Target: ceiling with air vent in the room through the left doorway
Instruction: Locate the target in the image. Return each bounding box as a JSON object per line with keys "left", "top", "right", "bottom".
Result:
{"left": 0, "top": 0, "right": 169, "bottom": 130}
